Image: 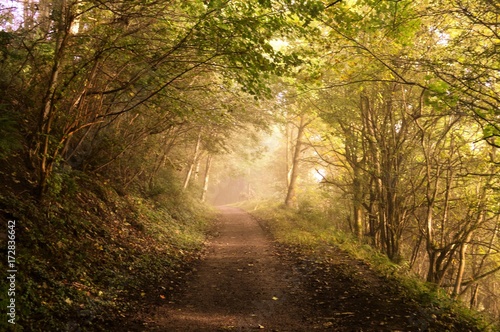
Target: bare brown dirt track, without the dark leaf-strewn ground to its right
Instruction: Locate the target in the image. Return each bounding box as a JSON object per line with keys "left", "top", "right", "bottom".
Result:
{"left": 144, "top": 207, "right": 307, "bottom": 332}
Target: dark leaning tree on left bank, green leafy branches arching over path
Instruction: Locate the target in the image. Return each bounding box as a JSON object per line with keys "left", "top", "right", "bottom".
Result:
{"left": 0, "top": 1, "right": 322, "bottom": 196}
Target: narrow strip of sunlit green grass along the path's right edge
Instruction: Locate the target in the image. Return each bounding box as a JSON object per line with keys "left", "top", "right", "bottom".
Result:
{"left": 240, "top": 201, "right": 500, "bottom": 331}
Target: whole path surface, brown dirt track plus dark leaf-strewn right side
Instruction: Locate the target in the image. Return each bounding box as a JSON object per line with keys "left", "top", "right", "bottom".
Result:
{"left": 116, "top": 207, "right": 482, "bottom": 332}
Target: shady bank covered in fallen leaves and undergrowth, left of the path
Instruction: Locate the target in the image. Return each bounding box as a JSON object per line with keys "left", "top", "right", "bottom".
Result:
{"left": 0, "top": 173, "right": 212, "bottom": 331}
